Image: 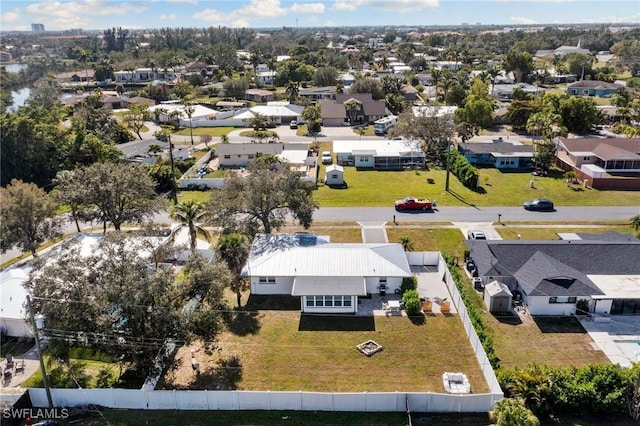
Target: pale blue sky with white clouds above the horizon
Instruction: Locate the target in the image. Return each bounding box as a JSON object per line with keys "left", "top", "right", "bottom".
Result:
{"left": 0, "top": 0, "right": 640, "bottom": 31}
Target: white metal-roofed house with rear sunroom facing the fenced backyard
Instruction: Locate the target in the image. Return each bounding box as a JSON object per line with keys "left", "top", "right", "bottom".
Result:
{"left": 242, "top": 234, "right": 412, "bottom": 314}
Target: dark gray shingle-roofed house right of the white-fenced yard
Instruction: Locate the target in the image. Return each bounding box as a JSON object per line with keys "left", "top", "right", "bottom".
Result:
{"left": 466, "top": 233, "right": 640, "bottom": 315}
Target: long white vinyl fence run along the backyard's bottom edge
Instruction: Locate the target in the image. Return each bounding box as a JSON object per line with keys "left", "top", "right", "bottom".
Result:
{"left": 29, "top": 388, "right": 496, "bottom": 413}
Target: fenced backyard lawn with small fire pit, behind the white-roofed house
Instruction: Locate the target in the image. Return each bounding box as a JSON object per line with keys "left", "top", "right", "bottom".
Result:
{"left": 164, "top": 308, "right": 488, "bottom": 393}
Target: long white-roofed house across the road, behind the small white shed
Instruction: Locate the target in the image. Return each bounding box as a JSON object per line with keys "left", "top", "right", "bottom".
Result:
{"left": 333, "top": 139, "right": 425, "bottom": 170}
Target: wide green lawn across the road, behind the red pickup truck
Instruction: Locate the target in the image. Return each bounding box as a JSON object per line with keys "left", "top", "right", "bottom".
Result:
{"left": 314, "top": 165, "right": 640, "bottom": 207}
